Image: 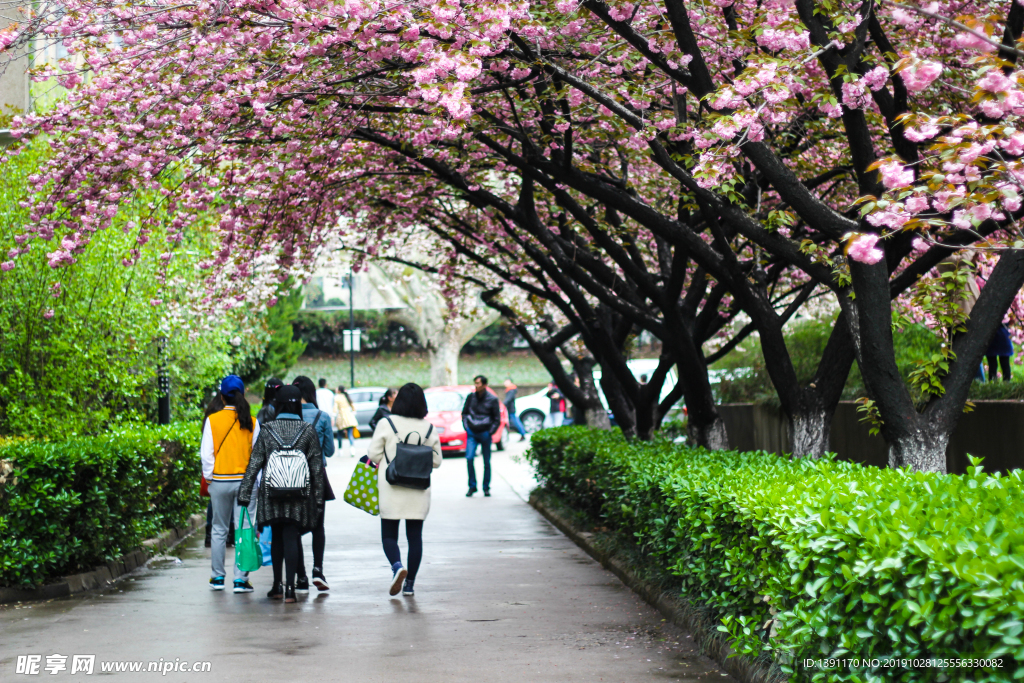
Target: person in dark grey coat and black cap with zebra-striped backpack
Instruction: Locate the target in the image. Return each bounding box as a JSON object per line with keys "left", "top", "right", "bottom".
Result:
{"left": 239, "top": 385, "right": 326, "bottom": 602}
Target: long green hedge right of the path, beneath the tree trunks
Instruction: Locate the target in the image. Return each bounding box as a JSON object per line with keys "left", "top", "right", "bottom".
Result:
{"left": 528, "top": 427, "right": 1024, "bottom": 682}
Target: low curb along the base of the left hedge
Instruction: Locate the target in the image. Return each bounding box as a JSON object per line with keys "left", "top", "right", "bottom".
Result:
{"left": 0, "top": 514, "right": 206, "bottom": 604}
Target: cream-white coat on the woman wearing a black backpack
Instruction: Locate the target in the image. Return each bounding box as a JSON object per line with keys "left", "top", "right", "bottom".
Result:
{"left": 367, "top": 415, "right": 441, "bottom": 519}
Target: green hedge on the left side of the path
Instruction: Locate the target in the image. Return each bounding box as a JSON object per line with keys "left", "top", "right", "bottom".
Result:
{"left": 0, "top": 425, "right": 203, "bottom": 587}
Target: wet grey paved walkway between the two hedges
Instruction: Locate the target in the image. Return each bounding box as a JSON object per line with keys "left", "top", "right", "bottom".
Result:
{"left": 0, "top": 440, "right": 732, "bottom": 683}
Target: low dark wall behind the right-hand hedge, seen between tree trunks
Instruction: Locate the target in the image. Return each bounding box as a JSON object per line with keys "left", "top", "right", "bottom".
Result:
{"left": 719, "top": 400, "right": 1024, "bottom": 474}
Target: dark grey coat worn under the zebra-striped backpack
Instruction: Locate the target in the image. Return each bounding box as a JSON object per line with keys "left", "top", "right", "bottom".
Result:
{"left": 239, "top": 415, "right": 324, "bottom": 531}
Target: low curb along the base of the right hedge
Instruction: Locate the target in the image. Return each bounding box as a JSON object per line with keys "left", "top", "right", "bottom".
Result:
{"left": 529, "top": 490, "right": 771, "bottom": 683}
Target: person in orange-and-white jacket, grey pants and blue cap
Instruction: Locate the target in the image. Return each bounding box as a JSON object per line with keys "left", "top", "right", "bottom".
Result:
{"left": 200, "top": 375, "right": 260, "bottom": 593}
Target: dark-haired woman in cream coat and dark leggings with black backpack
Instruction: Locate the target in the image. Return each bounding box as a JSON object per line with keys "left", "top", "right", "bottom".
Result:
{"left": 367, "top": 383, "right": 441, "bottom": 595}
